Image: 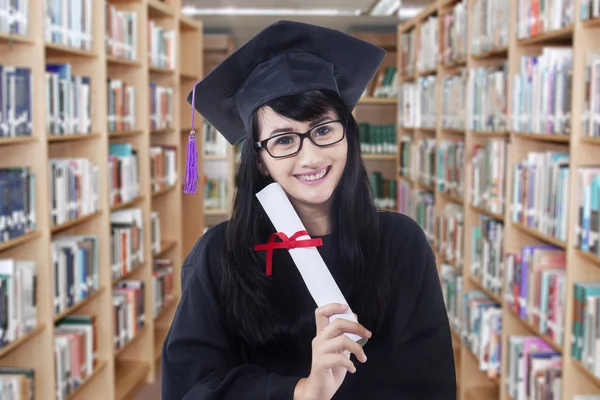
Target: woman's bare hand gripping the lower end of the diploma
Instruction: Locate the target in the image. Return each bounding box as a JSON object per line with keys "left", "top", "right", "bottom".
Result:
{"left": 294, "top": 303, "right": 371, "bottom": 400}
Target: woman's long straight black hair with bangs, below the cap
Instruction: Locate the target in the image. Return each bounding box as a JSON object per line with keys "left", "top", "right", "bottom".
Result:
{"left": 222, "top": 91, "right": 389, "bottom": 352}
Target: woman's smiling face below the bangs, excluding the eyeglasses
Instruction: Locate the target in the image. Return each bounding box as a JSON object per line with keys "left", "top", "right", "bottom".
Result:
{"left": 258, "top": 107, "right": 348, "bottom": 211}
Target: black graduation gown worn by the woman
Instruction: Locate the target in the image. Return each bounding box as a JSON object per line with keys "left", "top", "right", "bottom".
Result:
{"left": 162, "top": 212, "right": 456, "bottom": 400}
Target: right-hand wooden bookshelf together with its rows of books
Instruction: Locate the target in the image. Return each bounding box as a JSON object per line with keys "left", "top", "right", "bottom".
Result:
{"left": 397, "top": 0, "right": 588, "bottom": 400}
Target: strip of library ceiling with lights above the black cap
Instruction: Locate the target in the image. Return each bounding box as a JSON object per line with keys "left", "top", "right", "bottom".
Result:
{"left": 183, "top": 0, "right": 431, "bottom": 47}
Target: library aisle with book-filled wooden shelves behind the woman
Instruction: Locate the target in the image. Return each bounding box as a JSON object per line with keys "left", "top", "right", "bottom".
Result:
{"left": 0, "top": 0, "right": 600, "bottom": 400}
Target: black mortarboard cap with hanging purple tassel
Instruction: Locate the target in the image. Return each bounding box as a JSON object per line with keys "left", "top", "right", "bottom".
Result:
{"left": 184, "top": 21, "right": 386, "bottom": 193}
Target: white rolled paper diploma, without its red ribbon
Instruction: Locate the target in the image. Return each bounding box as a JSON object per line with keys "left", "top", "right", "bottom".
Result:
{"left": 256, "top": 182, "right": 366, "bottom": 345}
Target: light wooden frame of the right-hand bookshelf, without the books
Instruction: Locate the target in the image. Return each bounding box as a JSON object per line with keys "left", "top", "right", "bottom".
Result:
{"left": 397, "top": 0, "right": 600, "bottom": 400}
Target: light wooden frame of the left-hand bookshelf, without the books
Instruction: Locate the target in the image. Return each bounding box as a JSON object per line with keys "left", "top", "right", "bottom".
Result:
{"left": 0, "top": 0, "right": 204, "bottom": 400}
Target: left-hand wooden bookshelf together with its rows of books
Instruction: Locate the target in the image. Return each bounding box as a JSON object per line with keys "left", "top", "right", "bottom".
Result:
{"left": 0, "top": 0, "right": 204, "bottom": 400}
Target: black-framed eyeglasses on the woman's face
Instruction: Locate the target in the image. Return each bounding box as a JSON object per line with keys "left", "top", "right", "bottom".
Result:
{"left": 254, "top": 121, "right": 346, "bottom": 158}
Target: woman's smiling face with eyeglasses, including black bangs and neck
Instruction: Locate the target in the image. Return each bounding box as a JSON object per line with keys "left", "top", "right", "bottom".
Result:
{"left": 252, "top": 91, "right": 352, "bottom": 230}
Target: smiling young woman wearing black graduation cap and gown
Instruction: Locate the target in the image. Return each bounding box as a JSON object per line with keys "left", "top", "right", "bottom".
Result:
{"left": 162, "top": 21, "right": 456, "bottom": 400}
